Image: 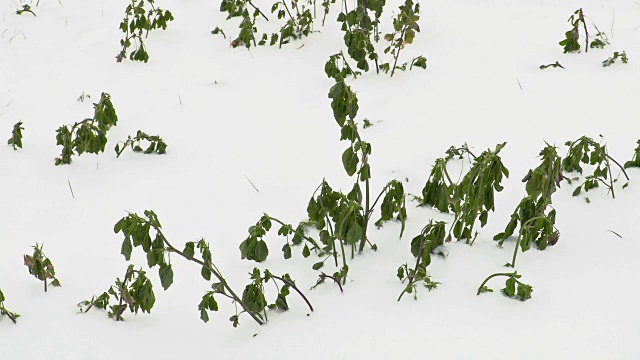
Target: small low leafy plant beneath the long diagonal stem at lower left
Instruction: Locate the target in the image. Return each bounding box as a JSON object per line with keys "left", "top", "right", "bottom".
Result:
{"left": 78, "top": 265, "right": 156, "bottom": 321}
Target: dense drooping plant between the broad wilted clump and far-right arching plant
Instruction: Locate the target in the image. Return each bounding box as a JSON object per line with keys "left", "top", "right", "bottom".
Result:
{"left": 493, "top": 144, "right": 564, "bottom": 267}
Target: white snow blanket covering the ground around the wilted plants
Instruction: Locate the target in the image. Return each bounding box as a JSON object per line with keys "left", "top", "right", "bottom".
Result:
{"left": 0, "top": 0, "right": 640, "bottom": 360}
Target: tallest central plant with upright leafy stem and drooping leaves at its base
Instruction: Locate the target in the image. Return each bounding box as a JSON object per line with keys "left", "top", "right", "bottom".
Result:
{"left": 240, "top": 61, "right": 407, "bottom": 284}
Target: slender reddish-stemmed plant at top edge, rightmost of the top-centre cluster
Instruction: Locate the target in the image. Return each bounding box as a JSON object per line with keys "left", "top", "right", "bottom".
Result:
{"left": 380, "top": 0, "right": 427, "bottom": 77}
